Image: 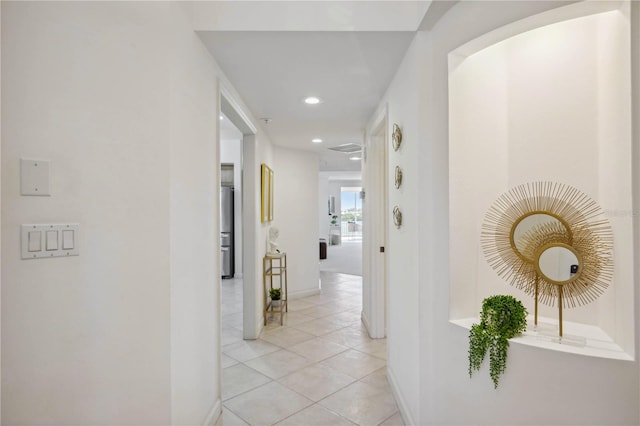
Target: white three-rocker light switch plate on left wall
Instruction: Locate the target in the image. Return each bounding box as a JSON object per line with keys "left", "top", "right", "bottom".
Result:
{"left": 20, "top": 223, "right": 80, "bottom": 259}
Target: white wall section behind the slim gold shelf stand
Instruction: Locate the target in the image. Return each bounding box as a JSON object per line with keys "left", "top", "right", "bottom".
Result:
{"left": 272, "top": 147, "right": 320, "bottom": 298}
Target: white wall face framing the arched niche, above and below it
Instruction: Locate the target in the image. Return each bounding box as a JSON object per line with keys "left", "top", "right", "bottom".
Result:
{"left": 412, "top": 1, "right": 640, "bottom": 425}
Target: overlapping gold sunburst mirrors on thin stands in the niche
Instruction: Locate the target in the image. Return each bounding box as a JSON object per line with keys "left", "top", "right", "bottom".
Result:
{"left": 481, "top": 182, "right": 613, "bottom": 337}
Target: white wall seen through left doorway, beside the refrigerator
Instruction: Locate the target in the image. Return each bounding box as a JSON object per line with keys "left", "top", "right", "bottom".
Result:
{"left": 220, "top": 139, "right": 243, "bottom": 278}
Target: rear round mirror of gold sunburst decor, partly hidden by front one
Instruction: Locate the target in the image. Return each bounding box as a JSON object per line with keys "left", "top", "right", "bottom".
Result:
{"left": 511, "top": 212, "right": 571, "bottom": 263}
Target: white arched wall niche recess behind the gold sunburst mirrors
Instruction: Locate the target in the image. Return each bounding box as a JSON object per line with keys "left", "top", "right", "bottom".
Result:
{"left": 449, "top": 1, "right": 637, "bottom": 360}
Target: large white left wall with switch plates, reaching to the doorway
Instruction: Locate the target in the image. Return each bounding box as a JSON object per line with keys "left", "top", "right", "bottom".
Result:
{"left": 2, "top": 2, "right": 220, "bottom": 425}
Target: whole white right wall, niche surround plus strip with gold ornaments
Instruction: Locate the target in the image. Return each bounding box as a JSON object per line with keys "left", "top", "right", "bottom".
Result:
{"left": 370, "top": 1, "right": 640, "bottom": 425}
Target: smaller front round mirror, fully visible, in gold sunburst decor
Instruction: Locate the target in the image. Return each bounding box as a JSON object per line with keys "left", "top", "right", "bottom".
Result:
{"left": 536, "top": 243, "right": 582, "bottom": 285}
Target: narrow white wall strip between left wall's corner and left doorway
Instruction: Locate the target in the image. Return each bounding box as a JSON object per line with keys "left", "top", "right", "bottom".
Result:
{"left": 168, "top": 3, "right": 221, "bottom": 425}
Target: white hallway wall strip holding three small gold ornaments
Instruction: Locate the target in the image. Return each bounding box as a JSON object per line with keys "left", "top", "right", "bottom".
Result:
{"left": 363, "top": 30, "right": 425, "bottom": 424}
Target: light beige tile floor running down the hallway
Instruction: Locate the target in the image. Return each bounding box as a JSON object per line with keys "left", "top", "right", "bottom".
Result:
{"left": 216, "top": 272, "right": 403, "bottom": 426}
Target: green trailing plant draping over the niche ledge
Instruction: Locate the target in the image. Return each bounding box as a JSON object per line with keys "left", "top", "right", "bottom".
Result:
{"left": 469, "top": 295, "right": 527, "bottom": 388}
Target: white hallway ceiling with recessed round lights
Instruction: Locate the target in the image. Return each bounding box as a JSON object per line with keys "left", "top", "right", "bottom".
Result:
{"left": 193, "top": 1, "right": 430, "bottom": 171}
